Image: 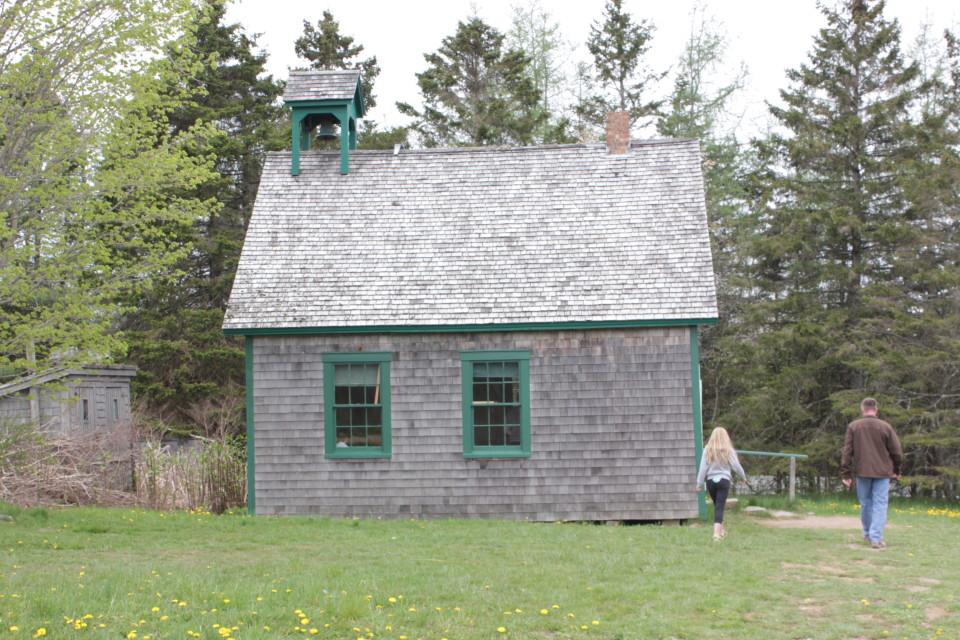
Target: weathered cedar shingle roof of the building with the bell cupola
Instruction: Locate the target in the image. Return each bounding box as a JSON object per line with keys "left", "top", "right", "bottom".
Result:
{"left": 224, "top": 139, "right": 717, "bottom": 333}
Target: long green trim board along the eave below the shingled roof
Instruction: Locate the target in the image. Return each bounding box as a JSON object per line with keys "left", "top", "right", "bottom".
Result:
{"left": 223, "top": 318, "right": 717, "bottom": 336}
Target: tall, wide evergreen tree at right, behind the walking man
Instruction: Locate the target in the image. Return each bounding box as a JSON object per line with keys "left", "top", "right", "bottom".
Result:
{"left": 721, "top": 0, "right": 960, "bottom": 492}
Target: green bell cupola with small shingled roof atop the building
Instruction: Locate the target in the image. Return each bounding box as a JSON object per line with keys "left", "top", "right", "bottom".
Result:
{"left": 283, "top": 70, "right": 365, "bottom": 176}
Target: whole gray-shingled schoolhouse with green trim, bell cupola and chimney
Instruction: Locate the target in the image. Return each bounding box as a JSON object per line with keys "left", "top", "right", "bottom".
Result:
{"left": 224, "top": 72, "right": 717, "bottom": 521}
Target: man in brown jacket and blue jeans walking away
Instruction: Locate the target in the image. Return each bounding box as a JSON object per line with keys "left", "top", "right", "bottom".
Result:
{"left": 840, "top": 398, "right": 903, "bottom": 549}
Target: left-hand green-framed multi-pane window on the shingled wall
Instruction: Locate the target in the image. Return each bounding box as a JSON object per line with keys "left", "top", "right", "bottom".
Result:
{"left": 323, "top": 351, "right": 391, "bottom": 459}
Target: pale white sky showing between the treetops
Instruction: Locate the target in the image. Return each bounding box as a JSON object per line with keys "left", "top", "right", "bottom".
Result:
{"left": 227, "top": 0, "right": 960, "bottom": 138}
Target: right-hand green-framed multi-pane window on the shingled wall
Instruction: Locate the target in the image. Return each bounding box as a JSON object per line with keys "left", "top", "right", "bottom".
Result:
{"left": 460, "top": 349, "right": 530, "bottom": 458}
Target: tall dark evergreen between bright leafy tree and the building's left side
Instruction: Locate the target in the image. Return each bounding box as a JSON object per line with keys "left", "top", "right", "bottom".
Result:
{"left": 123, "top": 0, "right": 290, "bottom": 431}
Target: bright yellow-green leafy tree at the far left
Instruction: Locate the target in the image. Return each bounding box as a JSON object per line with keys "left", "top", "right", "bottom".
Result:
{"left": 0, "top": 0, "right": 217, "bottom": 376}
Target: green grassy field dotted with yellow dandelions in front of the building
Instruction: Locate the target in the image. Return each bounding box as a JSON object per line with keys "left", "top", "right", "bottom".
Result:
{"left": 0, "top": 498, "right": 960, "bottom": 640}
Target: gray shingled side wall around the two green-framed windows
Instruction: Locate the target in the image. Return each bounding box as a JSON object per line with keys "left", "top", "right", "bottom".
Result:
{"left": 253, "top": 328, "right": 697, "bottom": 521}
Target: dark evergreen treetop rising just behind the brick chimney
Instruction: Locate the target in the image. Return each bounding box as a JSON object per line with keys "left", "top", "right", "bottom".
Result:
{"left": 578, "top": 0, "right": 667, "bottom": 131}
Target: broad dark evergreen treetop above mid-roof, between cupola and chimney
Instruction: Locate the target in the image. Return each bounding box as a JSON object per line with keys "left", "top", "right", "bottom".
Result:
{"left": 397, "top": 17, "right": 547, "bottom": 147}
